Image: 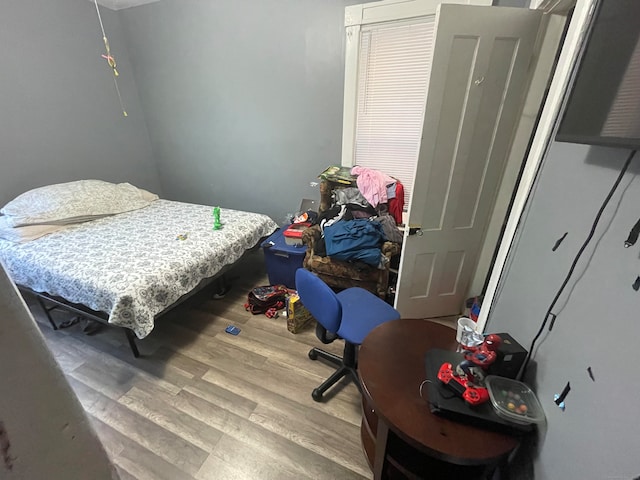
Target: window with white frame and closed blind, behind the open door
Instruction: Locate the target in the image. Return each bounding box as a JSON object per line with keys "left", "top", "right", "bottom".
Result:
{"left": 342, "top": 0, "right": 491, "bottom": 205}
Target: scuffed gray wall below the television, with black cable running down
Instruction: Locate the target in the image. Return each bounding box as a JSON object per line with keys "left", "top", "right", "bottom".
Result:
{"left": 488, "top": 143, "right": 640, "bottom": 480}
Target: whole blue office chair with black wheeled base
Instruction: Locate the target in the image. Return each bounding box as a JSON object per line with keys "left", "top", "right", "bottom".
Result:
{"left": 296, "top": 268, "right": 400, "bottom": 402}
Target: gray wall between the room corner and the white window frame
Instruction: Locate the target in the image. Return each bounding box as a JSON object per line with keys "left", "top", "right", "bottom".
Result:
{"left": 119, "top": 0, "right": 370, "bottom": 221}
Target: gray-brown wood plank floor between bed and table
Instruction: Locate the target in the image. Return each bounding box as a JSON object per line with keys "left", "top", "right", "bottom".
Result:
{"left": 28, "top": 251, "right": 378, "bottom": 480}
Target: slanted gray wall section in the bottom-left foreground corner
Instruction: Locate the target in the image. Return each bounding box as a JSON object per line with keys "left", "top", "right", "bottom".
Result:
{"left": 0, "top": 264, "right": 118, "bottom": 480}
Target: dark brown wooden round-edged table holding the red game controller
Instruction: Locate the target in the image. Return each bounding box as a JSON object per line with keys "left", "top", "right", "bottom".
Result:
{"left": 358, "top": 320, "right": 519, "bottom": 480}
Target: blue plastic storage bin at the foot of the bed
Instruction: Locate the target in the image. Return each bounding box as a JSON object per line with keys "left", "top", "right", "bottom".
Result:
{"left": 260, "top": 229, "right": 307, "bottom": 289}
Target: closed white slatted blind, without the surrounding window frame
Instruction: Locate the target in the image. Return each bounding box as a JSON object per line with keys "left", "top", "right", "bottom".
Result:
{"left": 354, "top": 15, "right": 435, "bottom": 206}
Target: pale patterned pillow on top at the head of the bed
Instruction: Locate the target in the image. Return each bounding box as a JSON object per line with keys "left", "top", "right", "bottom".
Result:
{"left": 0, "top": 180, "right": 158, "bottom": 227}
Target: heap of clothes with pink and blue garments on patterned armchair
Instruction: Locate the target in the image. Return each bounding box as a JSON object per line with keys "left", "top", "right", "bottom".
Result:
{"left": 315, "top": 166, "right": 404, "bottom": 269}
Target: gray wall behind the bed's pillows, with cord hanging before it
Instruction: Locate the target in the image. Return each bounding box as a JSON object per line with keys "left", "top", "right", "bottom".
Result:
{"left": 0, "top": 0, "right": 160, "bottom": 206}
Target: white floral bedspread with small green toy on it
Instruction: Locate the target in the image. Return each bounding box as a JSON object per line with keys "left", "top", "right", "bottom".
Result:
{"left": 0, "top": 200, "right": 278, "bottom": 338}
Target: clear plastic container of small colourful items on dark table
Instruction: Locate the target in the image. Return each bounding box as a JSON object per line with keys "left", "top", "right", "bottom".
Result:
{"left": 484, "top": 375, "right": 545, "bottom": 425}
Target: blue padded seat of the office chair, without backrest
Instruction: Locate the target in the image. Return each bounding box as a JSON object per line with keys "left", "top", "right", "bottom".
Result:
{"left": 337, "top": 287, "right": 400, "bottom": 345}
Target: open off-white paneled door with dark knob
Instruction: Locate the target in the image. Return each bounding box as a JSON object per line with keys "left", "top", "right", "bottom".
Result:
{"left": 396, "top": 4, "right": 541, "bottom": 318}
